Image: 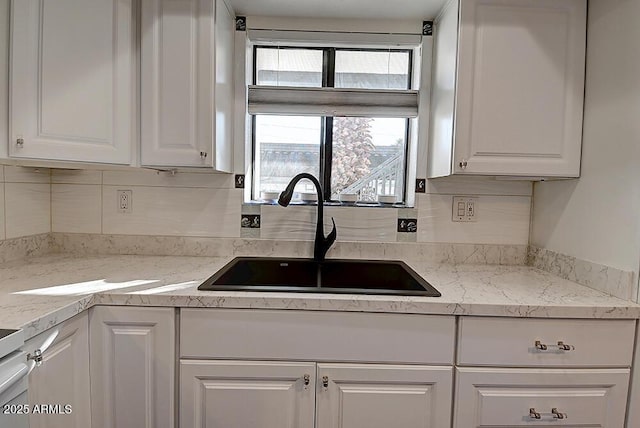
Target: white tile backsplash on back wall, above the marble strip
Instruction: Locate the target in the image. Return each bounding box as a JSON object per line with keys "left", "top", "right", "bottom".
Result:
{"left": 51, "top": 170, "right": 531, "bottom": 245}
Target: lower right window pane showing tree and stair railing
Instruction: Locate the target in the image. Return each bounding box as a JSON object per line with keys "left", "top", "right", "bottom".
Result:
{"left": 331, "top": 117, "right": 407, "bottom": 202}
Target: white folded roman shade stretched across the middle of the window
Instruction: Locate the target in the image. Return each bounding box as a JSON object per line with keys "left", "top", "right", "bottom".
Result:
{"left": 248, "top": 85, "right": 418, "bottom": 117}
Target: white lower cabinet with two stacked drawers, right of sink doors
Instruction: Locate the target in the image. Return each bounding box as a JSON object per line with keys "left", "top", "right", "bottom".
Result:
{"left": 454, "top": 317, "right": 636, "bottom": 428}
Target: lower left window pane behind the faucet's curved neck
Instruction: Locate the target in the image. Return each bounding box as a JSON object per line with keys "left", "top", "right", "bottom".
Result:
{"left": 253, "top": 115, "right": 322, "bottom": 199}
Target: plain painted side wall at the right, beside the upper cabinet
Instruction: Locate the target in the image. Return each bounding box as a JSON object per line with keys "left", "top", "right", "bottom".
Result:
{"left": 531, "top": 0, "right": 640, "bottom": 278}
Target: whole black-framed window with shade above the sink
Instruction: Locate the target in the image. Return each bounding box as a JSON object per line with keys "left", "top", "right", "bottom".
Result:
{"left": 249, "top": 45, "right": 417, "bottom": 202}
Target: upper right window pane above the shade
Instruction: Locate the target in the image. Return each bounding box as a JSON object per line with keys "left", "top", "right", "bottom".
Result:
{"left": 335, "top": 50, "right": 409, "bottom": 89}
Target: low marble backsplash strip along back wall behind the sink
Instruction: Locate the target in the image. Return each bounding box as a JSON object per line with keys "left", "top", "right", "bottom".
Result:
{"left": 51, "top": 233, "right": 527, "bottom": 265}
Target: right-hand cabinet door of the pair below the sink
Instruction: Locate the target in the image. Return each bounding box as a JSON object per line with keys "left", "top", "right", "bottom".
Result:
{"left": 316, "top": 364, "right": 453, "bottom": 428}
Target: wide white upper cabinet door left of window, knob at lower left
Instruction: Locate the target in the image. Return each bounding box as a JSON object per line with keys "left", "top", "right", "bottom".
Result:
{"left": 9, "top": 0, "right": 136, "bottom": 164}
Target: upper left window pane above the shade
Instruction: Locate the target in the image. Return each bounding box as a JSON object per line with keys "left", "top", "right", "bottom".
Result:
{"left": 256, "top": 48, "right": 322, "bottom": 87}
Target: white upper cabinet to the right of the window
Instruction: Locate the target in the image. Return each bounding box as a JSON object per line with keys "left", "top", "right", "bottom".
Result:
{"left": 428, "top": 0, "right": 587, "bottom": 177}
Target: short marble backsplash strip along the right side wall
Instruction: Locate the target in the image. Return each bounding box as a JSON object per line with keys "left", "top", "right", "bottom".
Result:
{"left": 527, "top": 246, "right": 637, "bottom": 301}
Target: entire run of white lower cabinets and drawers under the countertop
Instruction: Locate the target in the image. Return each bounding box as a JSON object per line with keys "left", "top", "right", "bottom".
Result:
{"left": 41, "top": 306, "right": 635, "bottom": 428}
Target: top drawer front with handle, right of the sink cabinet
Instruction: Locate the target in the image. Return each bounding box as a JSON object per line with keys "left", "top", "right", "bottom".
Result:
{"left": 458, "top": 317, "right": 635, "bottom": 367}
